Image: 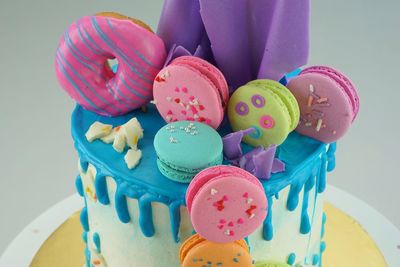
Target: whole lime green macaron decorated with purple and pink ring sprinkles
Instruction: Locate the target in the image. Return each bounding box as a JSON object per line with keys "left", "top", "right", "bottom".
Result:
{"left": 228, "top": 80, "right": 300, "bottom": 147}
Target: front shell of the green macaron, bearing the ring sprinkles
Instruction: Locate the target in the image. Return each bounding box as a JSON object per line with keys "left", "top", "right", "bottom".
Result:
{"left": 228, "top": 84, "right": 292, "bottom": 147}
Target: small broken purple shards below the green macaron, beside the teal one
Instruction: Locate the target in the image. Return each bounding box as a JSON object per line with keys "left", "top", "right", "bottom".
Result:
{"left": 222, "top": 128, "right": 285, "bottom": 179}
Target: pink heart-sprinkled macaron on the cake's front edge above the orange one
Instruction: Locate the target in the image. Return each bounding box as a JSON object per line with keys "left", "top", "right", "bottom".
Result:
{"left": 186, "top": 165, "right": 268, "bottom": 243}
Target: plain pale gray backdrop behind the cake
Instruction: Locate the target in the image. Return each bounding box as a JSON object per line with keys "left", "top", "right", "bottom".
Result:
{"left": 0, "top": 0, "right": 400, "bottom": 253}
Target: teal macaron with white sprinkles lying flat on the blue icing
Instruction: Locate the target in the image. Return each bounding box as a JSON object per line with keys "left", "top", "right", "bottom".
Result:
{"left": 154, "top": 121, "right": 223, "bottom": 183}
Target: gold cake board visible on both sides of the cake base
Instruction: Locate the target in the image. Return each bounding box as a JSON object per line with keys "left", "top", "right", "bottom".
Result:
{"left": 30, "top": 203, "right": 387, "bottom": 267}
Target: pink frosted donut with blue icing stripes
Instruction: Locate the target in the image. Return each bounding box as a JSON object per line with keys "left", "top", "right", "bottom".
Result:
{"left": 55, "top": 13, "right": 167, "bottom": 116}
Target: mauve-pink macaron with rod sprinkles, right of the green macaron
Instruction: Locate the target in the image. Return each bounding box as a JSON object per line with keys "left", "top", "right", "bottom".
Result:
{"left": 287, "top": 66, "right": 360, "bottom": 143}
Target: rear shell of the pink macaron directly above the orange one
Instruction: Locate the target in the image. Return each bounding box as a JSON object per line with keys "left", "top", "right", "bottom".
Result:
{"left": 186, "top": 165, "right": 263, "bottom": 212}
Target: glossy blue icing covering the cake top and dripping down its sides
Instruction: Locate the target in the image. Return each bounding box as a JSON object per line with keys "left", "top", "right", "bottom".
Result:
{"left": 72, "top": 105, "right": 326, "bottom": 242}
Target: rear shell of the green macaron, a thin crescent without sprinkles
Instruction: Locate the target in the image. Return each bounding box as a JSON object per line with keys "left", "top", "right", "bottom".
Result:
{"left": 249, "top": 80, "right": 300, "bottom": 131}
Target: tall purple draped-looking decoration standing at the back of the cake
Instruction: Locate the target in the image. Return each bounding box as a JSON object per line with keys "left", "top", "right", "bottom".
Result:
{"left": 158, "top": 0, "right": 309, "bottom": 88}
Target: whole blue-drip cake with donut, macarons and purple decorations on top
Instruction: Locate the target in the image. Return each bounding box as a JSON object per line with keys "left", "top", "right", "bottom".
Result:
{"left": 55, "top": 0, "right": 359, "bottom": 267}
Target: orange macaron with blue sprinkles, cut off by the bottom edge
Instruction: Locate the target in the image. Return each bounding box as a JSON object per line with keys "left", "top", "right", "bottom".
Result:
{"left": 181, "top": 237, "right": 253, "bottom": 267}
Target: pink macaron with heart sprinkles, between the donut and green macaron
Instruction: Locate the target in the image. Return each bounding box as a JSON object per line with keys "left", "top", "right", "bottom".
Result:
{"left": 153, "top": 56, "right": 229, "bottom": 129}
